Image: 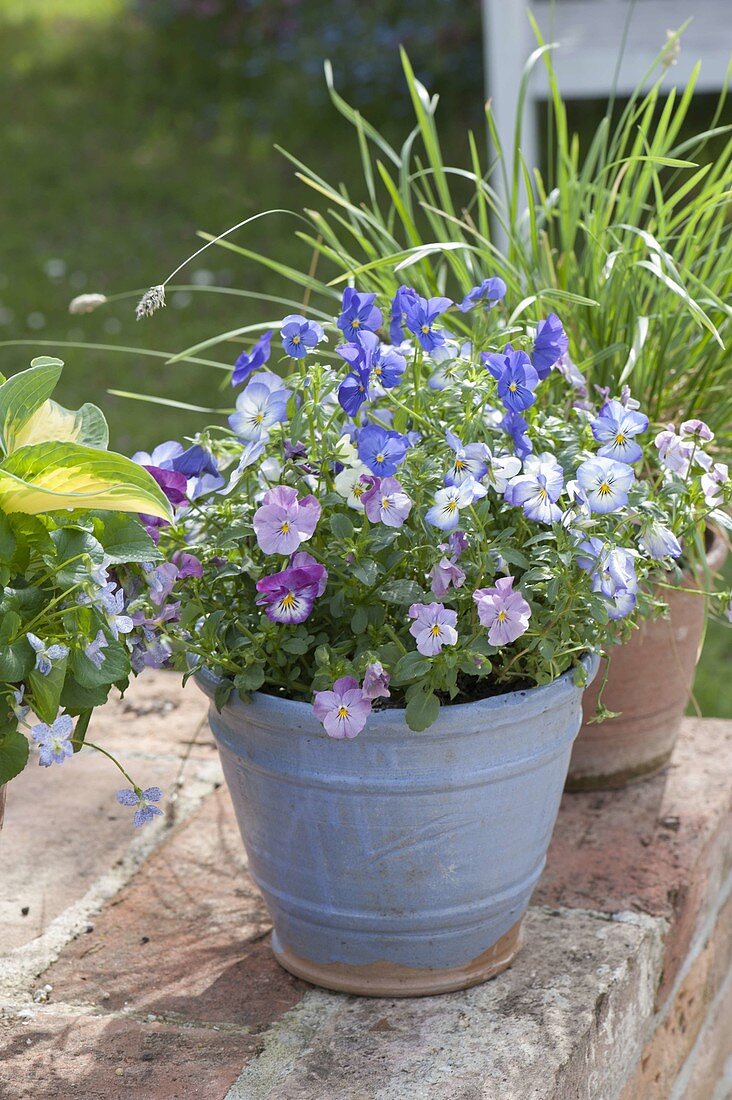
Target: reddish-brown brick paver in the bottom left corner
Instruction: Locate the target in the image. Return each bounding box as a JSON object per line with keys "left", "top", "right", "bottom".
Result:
{"left": 0, "top": 1007, "right": 260, "bottom": 1100}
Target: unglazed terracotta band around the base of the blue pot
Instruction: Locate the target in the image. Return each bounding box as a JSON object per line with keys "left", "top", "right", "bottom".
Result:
{"left": 272, "top": 916, "right": 523, "bottom": 997}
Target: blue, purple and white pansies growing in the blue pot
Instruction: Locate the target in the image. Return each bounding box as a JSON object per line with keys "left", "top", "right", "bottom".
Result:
{"left": 139, "top": 283, "right": 730, "bottom": 739}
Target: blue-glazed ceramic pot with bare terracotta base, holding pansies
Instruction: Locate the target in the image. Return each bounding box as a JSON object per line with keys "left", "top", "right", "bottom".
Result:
{"left": 197, "top": 660, "right": 597, "bottom": 997}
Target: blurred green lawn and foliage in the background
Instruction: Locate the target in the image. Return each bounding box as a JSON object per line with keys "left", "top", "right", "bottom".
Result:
{"left": 0, "top": 0, "right": 732, "bottom": 716}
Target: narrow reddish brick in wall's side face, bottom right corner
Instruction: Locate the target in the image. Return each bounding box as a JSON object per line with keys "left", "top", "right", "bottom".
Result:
{"left": 621, "top": 898, "right": 732, "bottom": 1100}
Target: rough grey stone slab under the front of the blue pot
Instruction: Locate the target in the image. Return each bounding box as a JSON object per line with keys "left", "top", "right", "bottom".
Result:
{"left": 227, "top": 910, "right": 663, "bottom": 1100}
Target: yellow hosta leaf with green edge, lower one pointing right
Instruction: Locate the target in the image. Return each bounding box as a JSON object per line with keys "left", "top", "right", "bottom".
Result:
{"left": 0, "top": 443, "right": 171, "bottom": 519}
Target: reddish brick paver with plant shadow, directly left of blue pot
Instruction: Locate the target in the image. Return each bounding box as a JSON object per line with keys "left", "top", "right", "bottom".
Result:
{"left": 40, "top": 789, "right": 306, "bottom": 1029}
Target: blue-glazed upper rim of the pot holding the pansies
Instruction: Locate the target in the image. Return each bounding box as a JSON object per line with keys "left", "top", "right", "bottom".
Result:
{"left": 194, "top": 652, "right": 600, "bottom": 740}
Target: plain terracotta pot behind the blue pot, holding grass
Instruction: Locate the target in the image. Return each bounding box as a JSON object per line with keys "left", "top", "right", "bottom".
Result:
{"left": 566, "top": 532, "right": 728, "bottom": 791}
